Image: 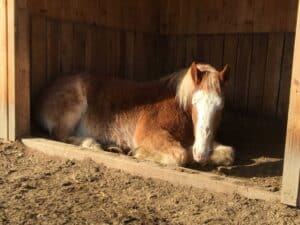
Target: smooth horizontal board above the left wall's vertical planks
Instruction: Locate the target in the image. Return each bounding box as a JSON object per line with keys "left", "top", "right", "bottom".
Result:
{"left": 27, "top": 0, "right": 159, "bottom": 32}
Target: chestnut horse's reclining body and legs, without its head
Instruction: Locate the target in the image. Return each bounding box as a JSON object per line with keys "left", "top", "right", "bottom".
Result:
{"left": 36, "top": 62, "right": 233, "bottom": 165}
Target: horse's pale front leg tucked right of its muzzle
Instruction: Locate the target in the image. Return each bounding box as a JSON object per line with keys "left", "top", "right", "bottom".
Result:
{"left": 208, "top": 142, "right": 235, "bottom": 166}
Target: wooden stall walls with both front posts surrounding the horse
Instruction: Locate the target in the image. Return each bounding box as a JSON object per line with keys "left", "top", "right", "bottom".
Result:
{"left": 0, "top": 0, "right": 300, "bottom": 205}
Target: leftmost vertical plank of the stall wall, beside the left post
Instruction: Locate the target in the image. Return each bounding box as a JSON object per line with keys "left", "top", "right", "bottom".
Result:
{"left": 30, "top": 16, "right": 47, "bottom": 100}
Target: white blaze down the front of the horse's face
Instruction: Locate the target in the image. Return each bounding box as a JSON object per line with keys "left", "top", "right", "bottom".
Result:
{"left": 192, "top": 90, "right": 223, "bottom": 161}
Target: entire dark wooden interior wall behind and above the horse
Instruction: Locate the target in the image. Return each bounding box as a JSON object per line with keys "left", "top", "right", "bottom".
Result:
{"left": 28, "top": 0, "right": 297, "bottom": 121}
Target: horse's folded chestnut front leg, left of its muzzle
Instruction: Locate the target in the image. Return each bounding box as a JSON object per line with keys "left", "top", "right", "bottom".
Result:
{"left": 133, "top": 128, "right": 189, "bottom": 166}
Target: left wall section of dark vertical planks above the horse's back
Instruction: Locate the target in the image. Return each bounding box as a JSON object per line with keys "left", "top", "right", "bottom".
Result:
{"left": 30, "top": 16, "right": 161, "bottom": 100}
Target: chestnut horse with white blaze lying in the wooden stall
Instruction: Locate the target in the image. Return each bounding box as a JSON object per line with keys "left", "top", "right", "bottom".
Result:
{"left": 35, "top": 62, "right": 234, "bottom": 166}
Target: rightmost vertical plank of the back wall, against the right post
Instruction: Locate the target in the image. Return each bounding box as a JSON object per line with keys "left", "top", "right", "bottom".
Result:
{"left": 277, "top": 33, "right": 295, "bottom": 123}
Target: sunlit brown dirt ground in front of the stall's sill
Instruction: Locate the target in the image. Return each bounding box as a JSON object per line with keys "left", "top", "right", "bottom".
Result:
{"left": 0, "top": 142, "right": 300, "bottom": 225}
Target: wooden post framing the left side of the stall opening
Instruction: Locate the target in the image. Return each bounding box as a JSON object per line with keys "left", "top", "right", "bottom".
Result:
{"left": 0, "top": 0, "right": 30, "bottom": 140}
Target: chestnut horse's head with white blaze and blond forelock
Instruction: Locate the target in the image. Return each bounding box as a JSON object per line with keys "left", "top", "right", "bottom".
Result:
{"left": 177, "top": 63, "right": 228, "bottom": 163}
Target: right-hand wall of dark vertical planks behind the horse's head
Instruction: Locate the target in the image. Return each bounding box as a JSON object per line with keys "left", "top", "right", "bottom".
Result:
{"left": 162, "top": 33, "right": 294, "bottom": 120}
